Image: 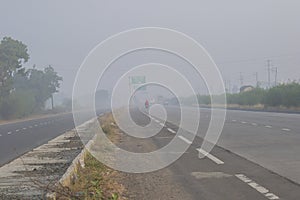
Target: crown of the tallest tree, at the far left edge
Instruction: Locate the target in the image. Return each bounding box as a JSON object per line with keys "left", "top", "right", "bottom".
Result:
{"left": 0, "top": 37, "right": 29, "bottom": 98}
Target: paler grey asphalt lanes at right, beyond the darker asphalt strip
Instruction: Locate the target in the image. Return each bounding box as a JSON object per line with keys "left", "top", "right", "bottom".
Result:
{"left": 151, "top": 106, "right": 300, "bottom": 184}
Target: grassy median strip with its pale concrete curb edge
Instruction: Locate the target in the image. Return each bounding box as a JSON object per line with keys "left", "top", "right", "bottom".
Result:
{"left": 47, "top": 114, "right": 125, "bottom": 200}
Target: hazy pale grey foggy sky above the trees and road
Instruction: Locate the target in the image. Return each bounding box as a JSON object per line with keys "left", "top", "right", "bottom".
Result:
{"left": 0, "top": 0, "right": 300, "bottom": 95}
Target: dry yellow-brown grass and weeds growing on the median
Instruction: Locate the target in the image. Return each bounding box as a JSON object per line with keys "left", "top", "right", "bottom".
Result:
{"left": 58, "top": 114, "right": 126, "bottom": 200}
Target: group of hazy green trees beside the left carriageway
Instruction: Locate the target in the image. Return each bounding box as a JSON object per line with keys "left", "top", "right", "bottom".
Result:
{"left": 0, "top": 37, "right": 62, "bottom": 119}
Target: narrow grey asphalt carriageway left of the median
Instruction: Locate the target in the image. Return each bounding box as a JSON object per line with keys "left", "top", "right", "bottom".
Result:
{"left": 0, "top": 111, "right": 102, "bottom": 166}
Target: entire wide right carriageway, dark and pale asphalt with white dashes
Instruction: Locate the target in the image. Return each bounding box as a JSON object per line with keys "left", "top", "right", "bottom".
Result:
{"left": 128, "top": 107, "right": 300, "bottom": 200}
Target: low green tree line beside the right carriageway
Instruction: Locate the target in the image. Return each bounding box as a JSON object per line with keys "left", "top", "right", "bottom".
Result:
{"left": 183, "top": 82, "right": 300, "bottom": 108}
